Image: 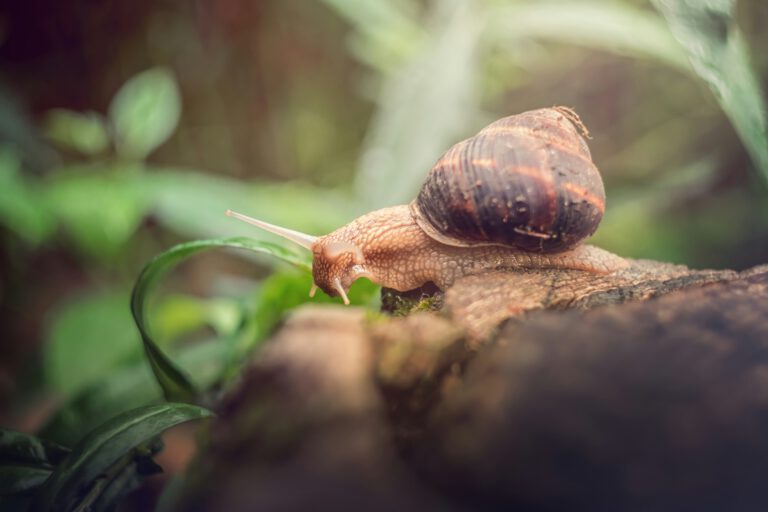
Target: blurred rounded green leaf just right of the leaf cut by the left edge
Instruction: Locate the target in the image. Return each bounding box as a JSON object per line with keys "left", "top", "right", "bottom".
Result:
{"left": 47, "top": 166, "right": 150, "bottom": 259}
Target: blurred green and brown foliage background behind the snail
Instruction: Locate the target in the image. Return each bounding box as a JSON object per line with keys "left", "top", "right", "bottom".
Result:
{"left": 0, "top": 0, "right": 768, "bottom": 504}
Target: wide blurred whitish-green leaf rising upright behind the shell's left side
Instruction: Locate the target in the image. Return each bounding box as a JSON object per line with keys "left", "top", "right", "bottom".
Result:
{"left": 356, "top": 0, "right": 486, "bottom": 208}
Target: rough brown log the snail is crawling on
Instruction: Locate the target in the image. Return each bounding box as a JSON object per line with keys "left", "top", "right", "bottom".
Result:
{"left": 178, "top": 262, "right": 768, "bottom": 511}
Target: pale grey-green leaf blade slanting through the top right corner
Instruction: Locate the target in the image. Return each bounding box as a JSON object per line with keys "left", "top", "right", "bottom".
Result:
{"left": 653, "top": 0, "right": 768, "bottom": 183}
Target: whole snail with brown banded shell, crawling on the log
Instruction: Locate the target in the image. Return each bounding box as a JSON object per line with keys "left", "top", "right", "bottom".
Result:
{"left": 227, "top": 107, "right": 627, "bottom": 304}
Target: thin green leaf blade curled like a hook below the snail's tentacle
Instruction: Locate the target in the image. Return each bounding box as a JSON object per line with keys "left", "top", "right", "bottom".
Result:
{"left": 131, "top": 238, "right": 310, "bottom": 400}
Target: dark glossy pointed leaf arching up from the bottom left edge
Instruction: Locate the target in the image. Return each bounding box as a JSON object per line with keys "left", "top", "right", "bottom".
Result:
{"left": 32, "top": 403, "right": 212, "bottom": 511}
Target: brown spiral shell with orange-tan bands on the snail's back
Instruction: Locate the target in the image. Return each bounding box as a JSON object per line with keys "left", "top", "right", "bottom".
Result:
{"left": 411, "top": 107, "right": 605, "bottom": 252}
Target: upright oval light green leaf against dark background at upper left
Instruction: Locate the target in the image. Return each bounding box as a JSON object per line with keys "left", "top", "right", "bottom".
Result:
{"left": 109, "top": 68, "right": 181, "bottom": 160}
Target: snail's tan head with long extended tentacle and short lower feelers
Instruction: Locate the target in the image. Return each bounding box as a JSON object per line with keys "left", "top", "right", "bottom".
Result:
{"left": 226, "top": 210, "right": 368, "bottom": 304}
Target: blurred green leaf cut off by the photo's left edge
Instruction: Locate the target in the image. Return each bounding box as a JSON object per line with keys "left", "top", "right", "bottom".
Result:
{"left": 0, "top": 147, "right": 56, "bottom": 244}
